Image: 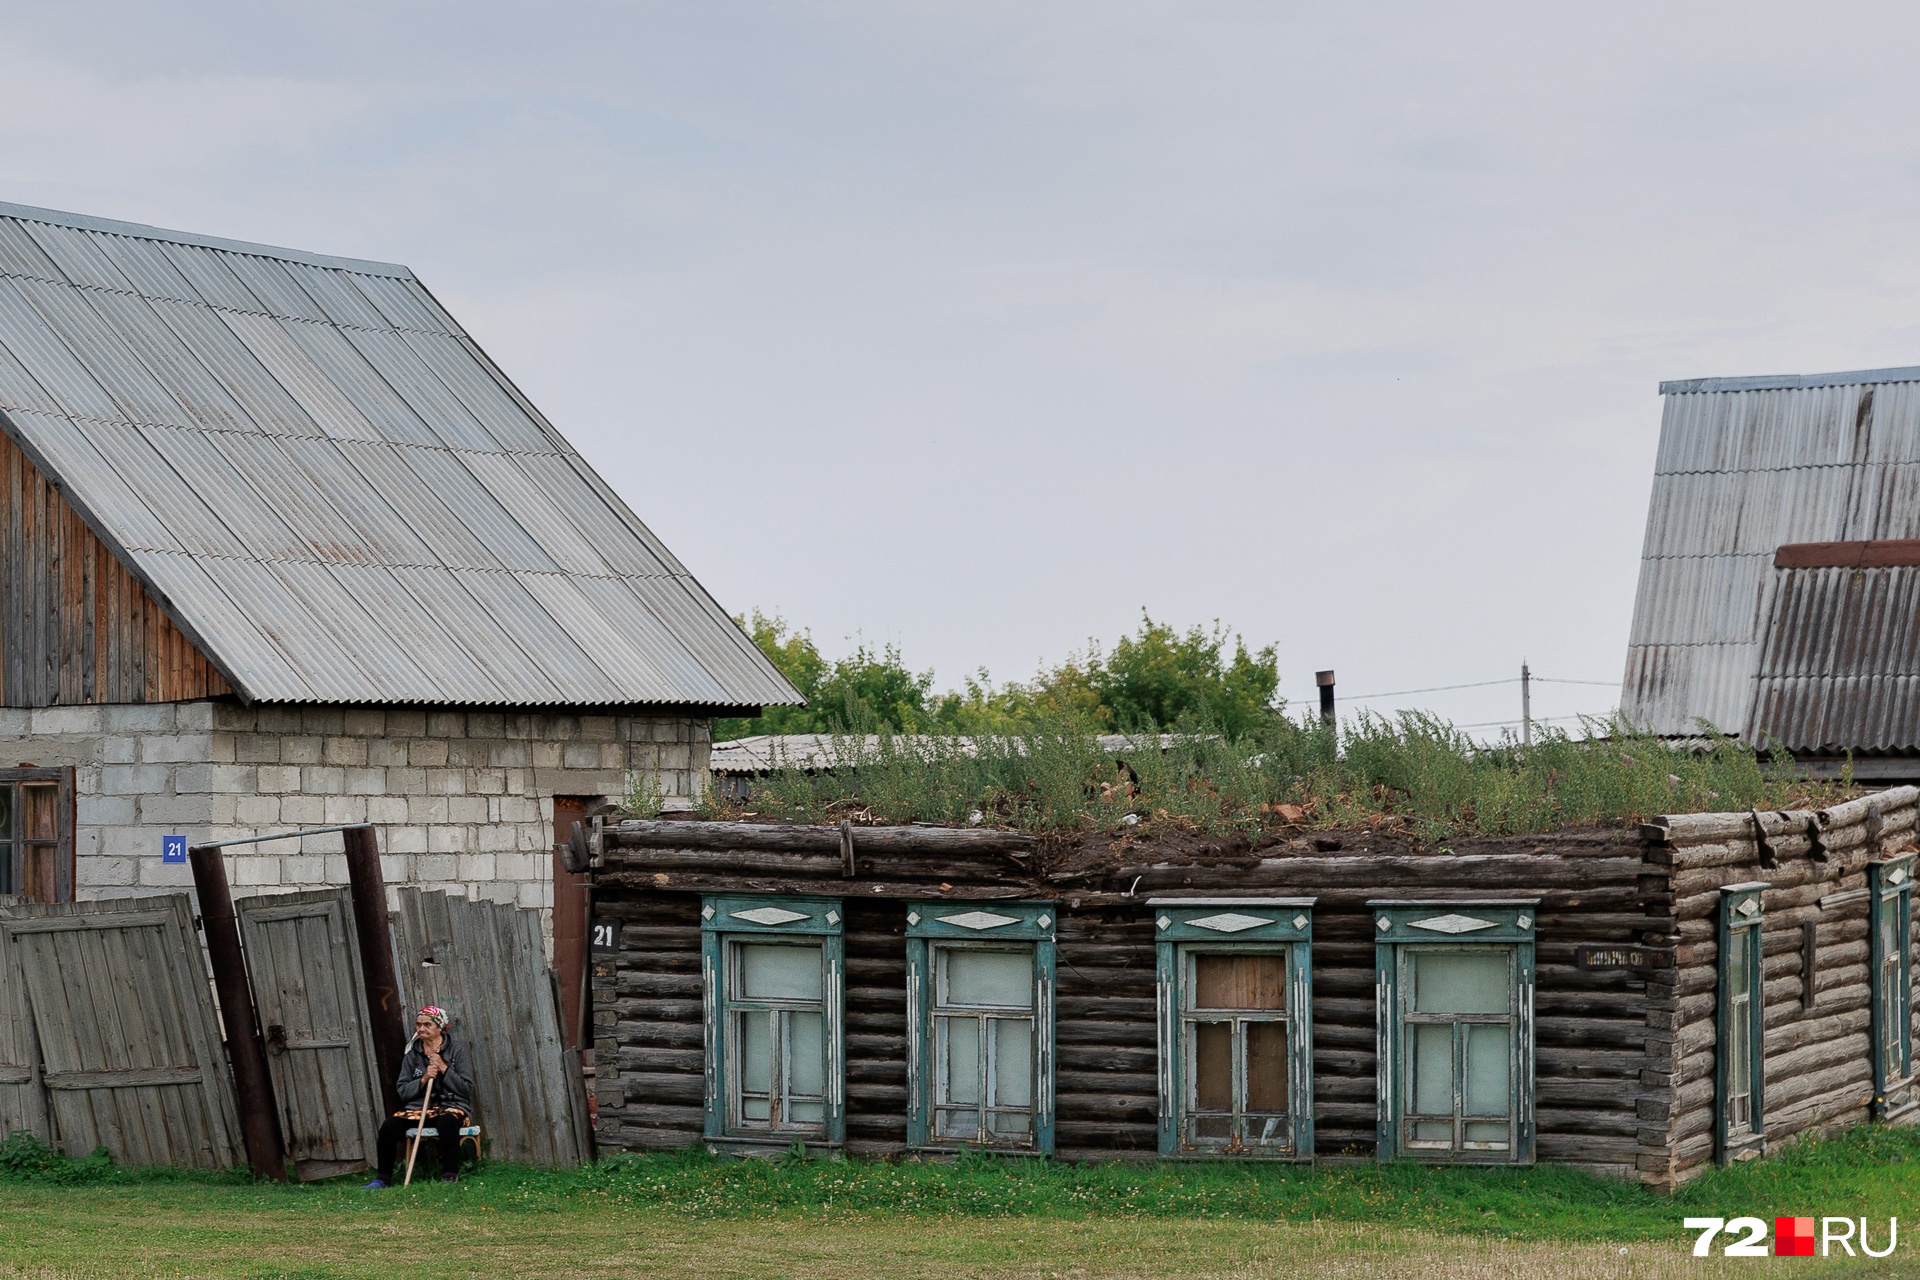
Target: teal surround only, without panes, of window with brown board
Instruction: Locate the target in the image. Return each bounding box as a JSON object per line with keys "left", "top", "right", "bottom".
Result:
{"left": 1146, "top": 898, "right": 1317, "bottom": 1161}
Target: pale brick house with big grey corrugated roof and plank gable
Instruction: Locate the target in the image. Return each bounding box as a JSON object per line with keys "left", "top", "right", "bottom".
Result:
{"left": 0, "top": 197, "right": 799, "bottom": 971}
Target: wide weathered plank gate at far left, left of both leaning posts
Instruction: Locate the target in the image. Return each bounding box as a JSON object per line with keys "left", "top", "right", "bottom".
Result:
{"left": 0, "top": 894, "right": 242, "bottom": 1169}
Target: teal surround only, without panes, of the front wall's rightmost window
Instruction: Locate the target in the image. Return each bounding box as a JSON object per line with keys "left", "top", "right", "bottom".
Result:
{"left": 1367, "top": 898, "right": 1540, "bottom": 1165}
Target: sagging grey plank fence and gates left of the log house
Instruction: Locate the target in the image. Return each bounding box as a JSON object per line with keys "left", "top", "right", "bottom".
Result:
{"left": 0, "top": 889, "right": 593, "bottom": 1180}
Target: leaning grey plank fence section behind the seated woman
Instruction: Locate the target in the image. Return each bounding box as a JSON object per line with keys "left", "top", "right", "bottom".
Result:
{"left": 394, "top": 889, "right": 591, "bottom": 1169}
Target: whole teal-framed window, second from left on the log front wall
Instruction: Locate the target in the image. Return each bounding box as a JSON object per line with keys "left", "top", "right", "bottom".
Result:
{"left": 906, "top": 902, "right": 1060, "bottom": 1155}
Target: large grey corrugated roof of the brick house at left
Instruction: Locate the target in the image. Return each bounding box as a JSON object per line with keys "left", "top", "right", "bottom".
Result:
{"left": 0, "top": 203, "right": 801, "bottom": 706}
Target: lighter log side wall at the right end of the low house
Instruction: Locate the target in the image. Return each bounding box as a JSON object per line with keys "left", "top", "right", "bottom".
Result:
{"left": 1640, "top": 787, "right": 1920, "bottom": 1190}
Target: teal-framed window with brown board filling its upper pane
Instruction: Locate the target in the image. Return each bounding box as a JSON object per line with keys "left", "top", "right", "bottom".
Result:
{"left": 1148, "top": 898, "right": 1315, "bottom": 1159}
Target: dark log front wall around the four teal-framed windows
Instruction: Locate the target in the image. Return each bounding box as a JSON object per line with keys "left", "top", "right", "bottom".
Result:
{"left": 593, "top": 829, "right": 1672, "bottom": 1176}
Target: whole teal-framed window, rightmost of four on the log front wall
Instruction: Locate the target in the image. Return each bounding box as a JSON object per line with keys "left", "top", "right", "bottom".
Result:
{"left": 1367, "top": 898, "right": 1538, "bottom": 1165}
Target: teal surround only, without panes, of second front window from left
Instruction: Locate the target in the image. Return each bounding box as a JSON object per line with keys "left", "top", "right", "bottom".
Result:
{"left": 906, "top": 900, "right": 1060, "bottom": 1155}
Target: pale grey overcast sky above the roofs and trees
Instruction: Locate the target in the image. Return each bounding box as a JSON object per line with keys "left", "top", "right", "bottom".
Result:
{"left": 0, "top": 0, "right": 1920, "bottom": 723}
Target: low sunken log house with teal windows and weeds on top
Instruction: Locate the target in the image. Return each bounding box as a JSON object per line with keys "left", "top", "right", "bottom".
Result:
{"left": 593, "top": 787, "right": 1920, "bottom": 1188}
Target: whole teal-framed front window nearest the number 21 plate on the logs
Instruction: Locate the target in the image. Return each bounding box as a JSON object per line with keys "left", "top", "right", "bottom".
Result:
{"left": 701, "top": 896, "right": 847, "bottom": 1150}
